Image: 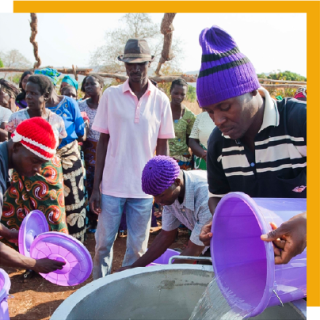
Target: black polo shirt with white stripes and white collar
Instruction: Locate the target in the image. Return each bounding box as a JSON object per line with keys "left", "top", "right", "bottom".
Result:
{"left": 207, "top": 88, "right": 306, "bottom": 198}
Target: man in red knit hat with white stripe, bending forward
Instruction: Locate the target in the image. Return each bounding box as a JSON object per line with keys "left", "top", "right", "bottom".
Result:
{"left": 0, "top": 117, "right": 64, "bottom": 273}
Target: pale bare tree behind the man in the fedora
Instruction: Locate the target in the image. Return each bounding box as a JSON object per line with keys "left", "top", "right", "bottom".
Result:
{"left": 90, "top": 13, "right": 182, "bottom": 73}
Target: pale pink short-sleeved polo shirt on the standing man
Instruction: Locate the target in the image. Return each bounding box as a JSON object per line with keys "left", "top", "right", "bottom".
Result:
{"left": 92, "top": 80, "right": 175, "bottom": 198}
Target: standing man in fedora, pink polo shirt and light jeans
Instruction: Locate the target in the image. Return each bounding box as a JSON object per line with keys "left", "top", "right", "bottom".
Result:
{"left": 90, "top": 39, "right": 175, "bottom": 279}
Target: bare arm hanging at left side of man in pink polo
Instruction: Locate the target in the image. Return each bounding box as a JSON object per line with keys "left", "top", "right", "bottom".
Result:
{"left": 90, "top": 133, "right": 110, "bottom": 214}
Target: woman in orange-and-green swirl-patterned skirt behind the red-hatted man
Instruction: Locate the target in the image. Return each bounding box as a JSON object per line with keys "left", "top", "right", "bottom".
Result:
{"left": 1, "top": 76, "right": 68, "bottom": 262}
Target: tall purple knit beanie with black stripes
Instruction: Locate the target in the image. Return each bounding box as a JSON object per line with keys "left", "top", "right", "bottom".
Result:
{"left": 197, "top": 26, "right": 260, "bottom": 107}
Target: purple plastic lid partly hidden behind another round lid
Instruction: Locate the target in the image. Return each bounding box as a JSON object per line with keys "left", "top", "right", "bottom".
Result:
{"left": 18, "top": 210, "right": 49, "bottom": 257}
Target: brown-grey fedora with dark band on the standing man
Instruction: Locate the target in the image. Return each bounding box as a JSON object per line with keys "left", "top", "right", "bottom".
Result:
{"left": 118, "top": 39, "right": 154, "bottom": 63}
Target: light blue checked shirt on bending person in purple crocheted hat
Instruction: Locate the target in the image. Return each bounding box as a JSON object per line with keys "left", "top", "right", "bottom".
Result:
{"left": 162, "top": 170, "right": 212, "bottom": 246}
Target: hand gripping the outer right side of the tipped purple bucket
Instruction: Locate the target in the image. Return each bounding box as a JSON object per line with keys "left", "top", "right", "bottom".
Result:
{"left": 261, "top": 212, "right": 307, "bottom": 264}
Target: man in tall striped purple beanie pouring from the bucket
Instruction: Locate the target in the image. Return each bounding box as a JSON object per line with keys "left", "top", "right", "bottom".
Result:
{"left": 197, "top": 26, "right": 307, "bottom": 263}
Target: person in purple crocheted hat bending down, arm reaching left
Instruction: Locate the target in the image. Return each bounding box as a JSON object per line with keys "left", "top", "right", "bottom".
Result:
{"left": 119, "top": 156, "right": 211, "bottom": 271}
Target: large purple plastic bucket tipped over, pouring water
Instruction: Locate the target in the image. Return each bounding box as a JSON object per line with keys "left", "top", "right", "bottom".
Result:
{"left": 210, "top": 192, "right": 307, "bottom": 317}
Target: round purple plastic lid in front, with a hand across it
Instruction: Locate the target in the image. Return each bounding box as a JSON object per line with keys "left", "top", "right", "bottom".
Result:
{"left": 30, "top": 231, "right": 92, "bottom": 286}
